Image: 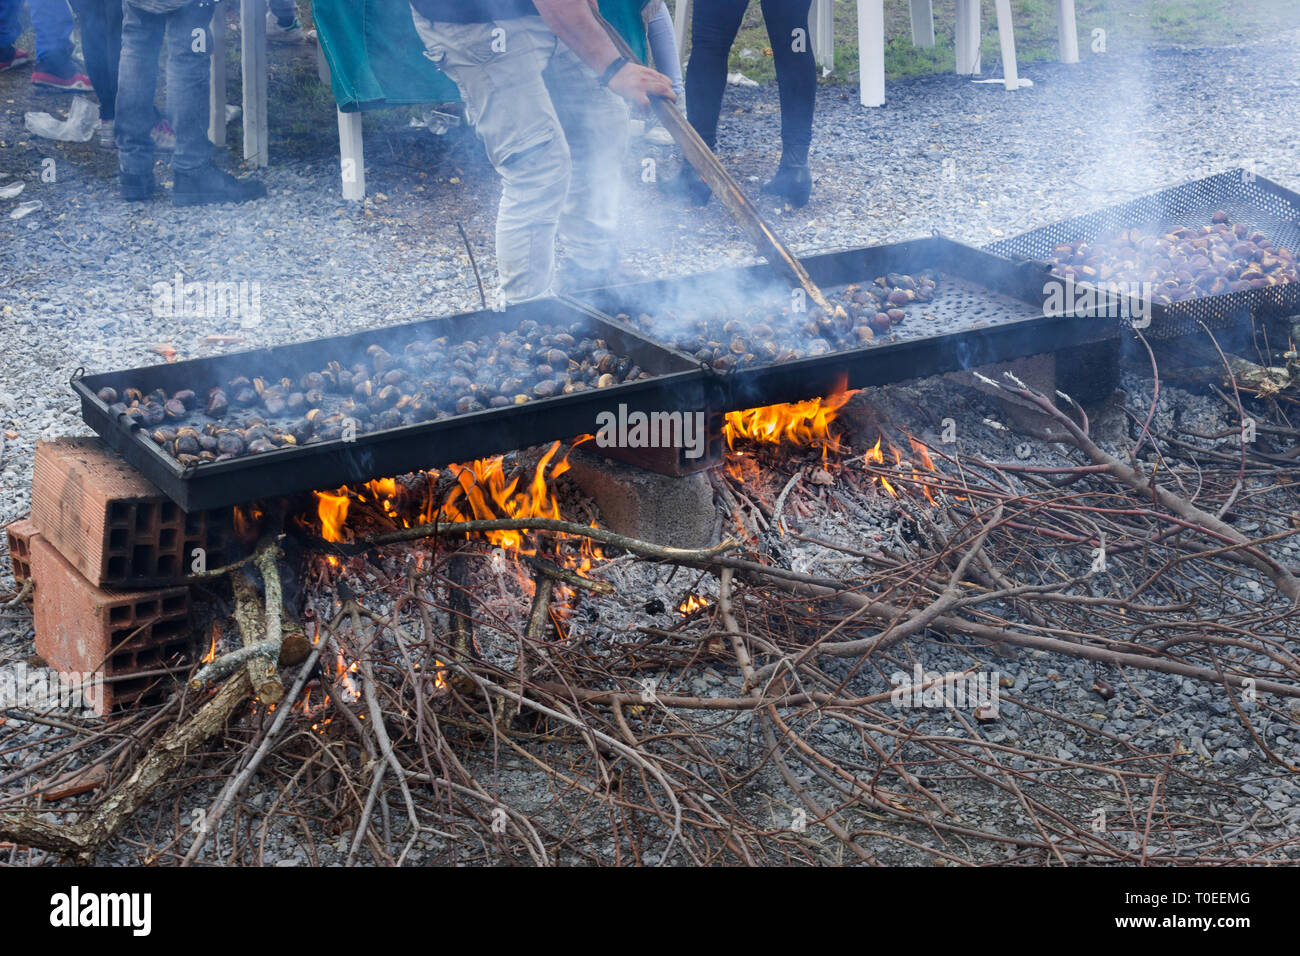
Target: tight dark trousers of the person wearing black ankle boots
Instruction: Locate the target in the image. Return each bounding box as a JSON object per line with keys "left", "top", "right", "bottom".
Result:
{"left": 686, "top": 0, "right": 816, "bottom": 164}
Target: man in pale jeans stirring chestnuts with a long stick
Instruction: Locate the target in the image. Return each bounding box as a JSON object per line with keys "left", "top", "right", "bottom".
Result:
{"left": 411, "top": 0, "right": 675, "bottom": 304}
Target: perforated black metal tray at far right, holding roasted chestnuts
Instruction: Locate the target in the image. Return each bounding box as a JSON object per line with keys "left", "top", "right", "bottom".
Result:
{"left": 984, "top": 169, "right": 1300, "bottom": 338}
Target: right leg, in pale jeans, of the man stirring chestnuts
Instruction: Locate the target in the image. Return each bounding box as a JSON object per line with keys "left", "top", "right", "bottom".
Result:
{"left": 543, "top": 37, "right": 628, "bottom": 272}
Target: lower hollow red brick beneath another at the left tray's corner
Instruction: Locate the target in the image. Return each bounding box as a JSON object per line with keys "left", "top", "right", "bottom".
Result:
{"left": 31, "top": 535, "right": 191, "bottom": 715}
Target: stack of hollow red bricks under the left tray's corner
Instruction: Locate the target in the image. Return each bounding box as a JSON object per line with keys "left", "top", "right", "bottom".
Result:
{"left": 7, "top": 438, "right": 226, "bottom": 715}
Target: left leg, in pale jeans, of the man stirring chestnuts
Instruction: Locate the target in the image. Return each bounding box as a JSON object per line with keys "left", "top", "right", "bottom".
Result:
{"left": 412, "top": 13, "right": 572, "bottom": 303}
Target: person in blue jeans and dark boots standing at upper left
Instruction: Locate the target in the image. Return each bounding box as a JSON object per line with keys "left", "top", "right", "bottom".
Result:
{"left": 114, "top": 0, "right": 267, "bottom": 206}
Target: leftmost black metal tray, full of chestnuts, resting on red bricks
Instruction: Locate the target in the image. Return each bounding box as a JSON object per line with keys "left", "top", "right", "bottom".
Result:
{"left": 73, "top": 299, "right": 718, "bottom": 511}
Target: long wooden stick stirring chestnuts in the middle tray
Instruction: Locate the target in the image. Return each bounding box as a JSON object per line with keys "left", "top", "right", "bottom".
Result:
{"left": 592, "top": 9, "right": 846, "bottom": 317}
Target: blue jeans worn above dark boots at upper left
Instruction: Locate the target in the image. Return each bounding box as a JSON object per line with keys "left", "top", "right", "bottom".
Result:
{"left": 114, "top": 0, "right": 212, "bottom": 176}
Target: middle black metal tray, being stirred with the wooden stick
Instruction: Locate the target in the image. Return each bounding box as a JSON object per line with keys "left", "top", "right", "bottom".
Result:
{"left": 573, "top": 235, "right": 1119, "bottom": 411}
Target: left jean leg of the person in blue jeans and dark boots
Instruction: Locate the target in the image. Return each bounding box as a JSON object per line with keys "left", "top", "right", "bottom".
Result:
{"left": 114, "top": 0, "right": 166, "bottom": 179}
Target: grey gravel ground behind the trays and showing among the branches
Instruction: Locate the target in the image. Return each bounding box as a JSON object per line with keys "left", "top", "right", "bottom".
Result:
{"left": 0, "top": 31, "right": 1300, "bottom": 862}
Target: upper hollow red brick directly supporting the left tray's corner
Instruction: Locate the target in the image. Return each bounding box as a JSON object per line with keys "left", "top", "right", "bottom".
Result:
{"left": 31, "top": 438, "right": 225, "bottom": 588}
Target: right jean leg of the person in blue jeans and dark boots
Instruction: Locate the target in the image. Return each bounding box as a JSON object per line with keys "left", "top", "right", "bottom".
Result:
{"left": 166, "top": 3, "right": 212, "bottom": 172}
